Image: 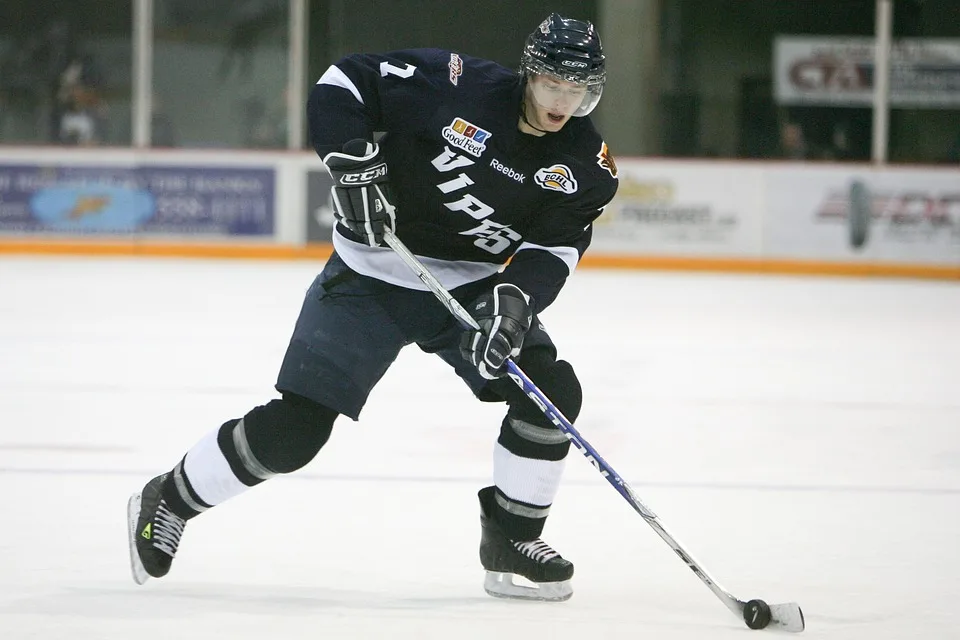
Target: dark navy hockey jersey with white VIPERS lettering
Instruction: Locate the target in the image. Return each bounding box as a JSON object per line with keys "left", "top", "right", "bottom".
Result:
{"left": 308, "top": 49, "right": 617, "bottom": 311}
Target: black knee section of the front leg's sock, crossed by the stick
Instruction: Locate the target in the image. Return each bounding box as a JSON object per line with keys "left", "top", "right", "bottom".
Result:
{"left": 498, "top": 353, "right": 583, "bottom": 460}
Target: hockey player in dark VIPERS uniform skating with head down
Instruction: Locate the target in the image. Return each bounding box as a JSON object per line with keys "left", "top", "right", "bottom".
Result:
{"left": 128, "top": 14, "right": 617, "bottom": 600}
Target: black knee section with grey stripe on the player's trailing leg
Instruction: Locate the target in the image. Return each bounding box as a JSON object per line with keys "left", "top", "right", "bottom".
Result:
{"left": 219, "top": 393, "right": 339, "bottom": 478}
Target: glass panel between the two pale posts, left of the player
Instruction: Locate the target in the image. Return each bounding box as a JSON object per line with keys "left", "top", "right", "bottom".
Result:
{"left": 152, "top": 0, "right": 289, "bottom": 149}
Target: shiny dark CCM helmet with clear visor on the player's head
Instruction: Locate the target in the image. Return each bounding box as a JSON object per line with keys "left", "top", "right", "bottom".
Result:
{"left": 520, "top": 13, "right": 607, "bottom": 116}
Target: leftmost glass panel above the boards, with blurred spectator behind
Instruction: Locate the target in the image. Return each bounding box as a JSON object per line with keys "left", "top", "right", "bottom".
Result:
{"left": 0, "top": 0, "right": 133, "bottom": 146}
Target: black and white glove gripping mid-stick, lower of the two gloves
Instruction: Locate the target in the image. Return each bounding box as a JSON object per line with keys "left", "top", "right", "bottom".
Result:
{"left": 460, "top": 284, "right": 533, "bottom": 380}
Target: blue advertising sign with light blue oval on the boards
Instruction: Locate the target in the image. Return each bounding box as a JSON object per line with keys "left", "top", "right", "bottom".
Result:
{"left": 0, "top": 165, "right": 275, "bottom": 236}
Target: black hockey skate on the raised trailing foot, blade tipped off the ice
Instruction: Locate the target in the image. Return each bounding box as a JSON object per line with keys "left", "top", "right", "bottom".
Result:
{"left": 127, "top": 474, "right": 187, "bottom": 584}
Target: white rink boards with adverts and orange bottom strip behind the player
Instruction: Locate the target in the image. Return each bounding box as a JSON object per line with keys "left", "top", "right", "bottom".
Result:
{"left": 0, "top": 148, "right": 960, "bottom": 279}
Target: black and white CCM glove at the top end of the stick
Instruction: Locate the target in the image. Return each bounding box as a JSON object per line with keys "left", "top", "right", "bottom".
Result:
{"left": 323, "top": 139, "right": 396, "bottom": 247}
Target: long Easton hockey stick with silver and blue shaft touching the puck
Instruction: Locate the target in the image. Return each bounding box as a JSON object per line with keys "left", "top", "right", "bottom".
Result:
{"left": 383, "top": 229, "right": 804, "bottom": 632}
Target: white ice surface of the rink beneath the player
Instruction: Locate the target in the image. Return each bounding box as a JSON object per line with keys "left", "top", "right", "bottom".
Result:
{"left": 0, "top": 257, "right": 960, "bottom": 640}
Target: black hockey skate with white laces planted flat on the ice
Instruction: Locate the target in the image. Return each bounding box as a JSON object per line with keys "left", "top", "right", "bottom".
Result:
{"left": 480, "top": 487, "right": 573, "bottom": 601}
